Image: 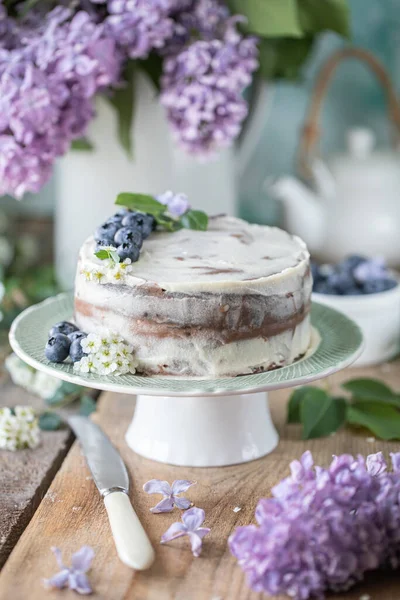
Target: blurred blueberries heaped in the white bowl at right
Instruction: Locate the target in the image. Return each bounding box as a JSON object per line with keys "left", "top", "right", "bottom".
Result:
{"left": 311, "top": 255, "right": 398, "bottom": 296}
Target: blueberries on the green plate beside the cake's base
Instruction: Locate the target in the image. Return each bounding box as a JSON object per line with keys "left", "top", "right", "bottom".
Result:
{"left": 44, "top": 321, "right": 87, "bottom": 363}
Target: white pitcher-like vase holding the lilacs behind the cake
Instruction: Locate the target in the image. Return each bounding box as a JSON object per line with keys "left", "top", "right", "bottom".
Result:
{"left": 55, "top": 75, "right": 265, "bottom": 289}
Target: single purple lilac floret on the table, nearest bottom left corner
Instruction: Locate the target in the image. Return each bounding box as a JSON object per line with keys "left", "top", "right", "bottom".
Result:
{"left": 43, "top": 546, "right": 94, "bottom": 594}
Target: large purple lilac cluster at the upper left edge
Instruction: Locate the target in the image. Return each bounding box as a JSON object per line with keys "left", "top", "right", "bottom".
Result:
{"left": 0, "top": 7, "right": 122, "bottom": 198}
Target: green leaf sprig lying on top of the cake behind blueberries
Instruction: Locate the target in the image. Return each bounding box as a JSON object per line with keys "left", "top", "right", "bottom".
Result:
{"left": 115, "top": 192, "right": 208, "bottom": 231}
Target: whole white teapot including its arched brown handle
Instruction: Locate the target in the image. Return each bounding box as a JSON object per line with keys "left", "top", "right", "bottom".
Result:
{"left": 270, "top": 48, "right": 400, "bottom": 266}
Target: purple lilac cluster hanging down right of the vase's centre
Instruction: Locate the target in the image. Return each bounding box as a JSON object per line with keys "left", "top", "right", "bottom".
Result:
{"left": 161, "top": 0, "right": 258, "bottom": 156}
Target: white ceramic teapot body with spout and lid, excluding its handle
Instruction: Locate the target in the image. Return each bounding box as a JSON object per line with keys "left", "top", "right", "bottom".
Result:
{"left": 270, "top": 129, "right": 400, "bottom": 265}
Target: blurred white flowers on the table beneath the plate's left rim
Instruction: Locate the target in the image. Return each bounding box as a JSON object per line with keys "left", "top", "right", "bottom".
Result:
{"left": 4, "top": 353, "right": 62, "bottom": 400}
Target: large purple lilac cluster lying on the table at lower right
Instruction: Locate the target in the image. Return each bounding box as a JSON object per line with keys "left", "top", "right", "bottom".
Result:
{"left": 229, "top": 452, "right": 400, "bottom": 600}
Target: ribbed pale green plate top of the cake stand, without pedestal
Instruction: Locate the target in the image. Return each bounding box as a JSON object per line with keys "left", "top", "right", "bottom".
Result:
{"left": 10, "top": 294, "right": 363, "bottom": 396}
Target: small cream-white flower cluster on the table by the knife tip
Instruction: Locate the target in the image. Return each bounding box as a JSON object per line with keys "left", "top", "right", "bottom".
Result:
{"left": 0, "top": 406, "right": 40, "bottom": 451}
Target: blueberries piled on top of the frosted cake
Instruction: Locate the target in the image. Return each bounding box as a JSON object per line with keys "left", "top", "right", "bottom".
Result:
{"left": 94, "top": 208, "right": 156, "bottom": 262}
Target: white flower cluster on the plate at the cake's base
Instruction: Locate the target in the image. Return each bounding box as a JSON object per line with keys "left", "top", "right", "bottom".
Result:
{"left": 74, "top": 333, "right": 138, "bottom": 375}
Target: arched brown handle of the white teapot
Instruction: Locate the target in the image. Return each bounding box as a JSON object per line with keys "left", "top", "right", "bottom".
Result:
{"left": 298, "top": 48, "right": 400, "bottom": 179}
